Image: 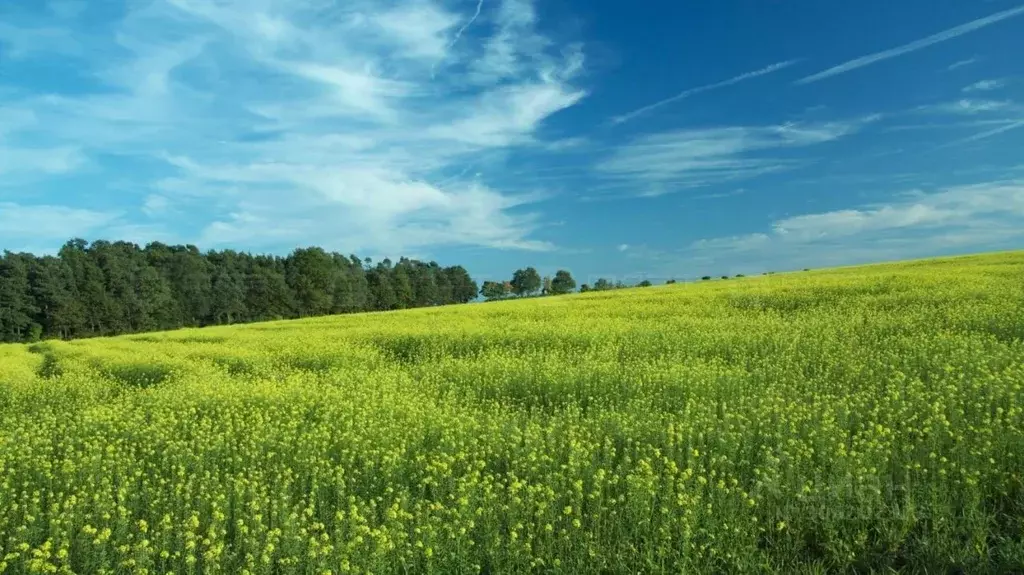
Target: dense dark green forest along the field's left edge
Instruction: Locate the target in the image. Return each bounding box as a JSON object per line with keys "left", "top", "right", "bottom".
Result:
{"left": 0, "top": 239, "right": 477, "bottom": 342}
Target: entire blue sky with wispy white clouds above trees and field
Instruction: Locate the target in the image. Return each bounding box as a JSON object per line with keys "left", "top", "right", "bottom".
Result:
{"left": 0, "top": 0, "right": 1024, "bottom": 281}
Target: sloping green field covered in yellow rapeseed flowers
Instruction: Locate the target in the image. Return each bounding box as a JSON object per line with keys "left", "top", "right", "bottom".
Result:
{"left": 0, "top": 253, "right": 1024, "bottom": 574}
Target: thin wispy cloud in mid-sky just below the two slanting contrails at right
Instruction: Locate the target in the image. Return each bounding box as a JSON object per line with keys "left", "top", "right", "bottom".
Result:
{"left": 597, "top": 115, "right": 881, "bottom": 196}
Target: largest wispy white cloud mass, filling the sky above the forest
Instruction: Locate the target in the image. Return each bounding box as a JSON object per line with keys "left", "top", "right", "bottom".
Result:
{"left": 0, "top": 0, "right": 587, "bottom": 254}
